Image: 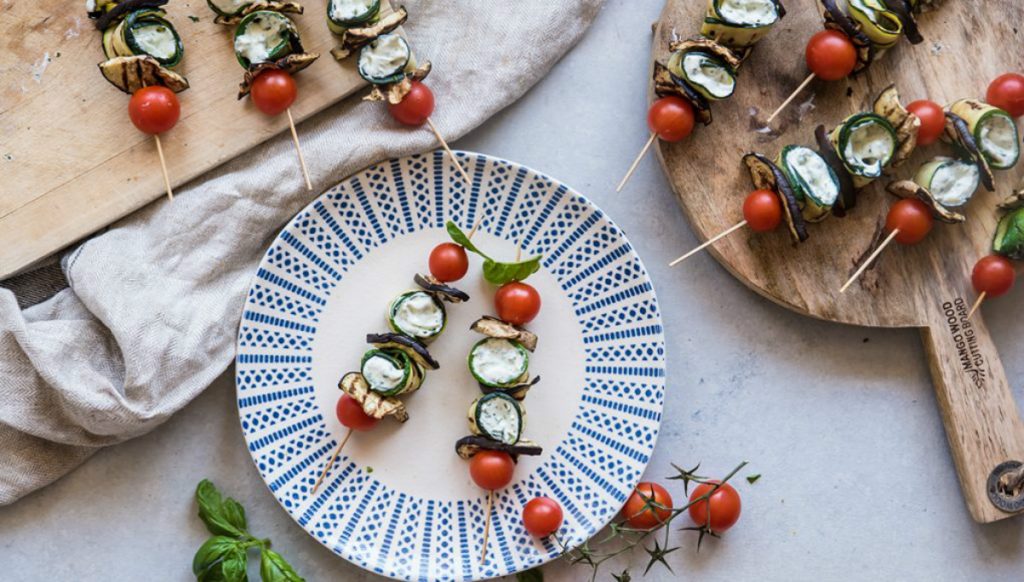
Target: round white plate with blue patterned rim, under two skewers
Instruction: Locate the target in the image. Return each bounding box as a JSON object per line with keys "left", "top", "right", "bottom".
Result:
{"left": 236, "top": 152, "right": 665, "bottom": 580}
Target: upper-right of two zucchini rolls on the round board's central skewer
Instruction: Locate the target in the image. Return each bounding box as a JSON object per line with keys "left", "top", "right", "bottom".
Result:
{"left": 831, "top": 113, "right": 897, "bottom": 188}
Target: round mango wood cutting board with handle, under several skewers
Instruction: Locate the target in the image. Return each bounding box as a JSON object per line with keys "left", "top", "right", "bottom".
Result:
{"left": 651, "top": 0, "right": 1024, "bottom": 523}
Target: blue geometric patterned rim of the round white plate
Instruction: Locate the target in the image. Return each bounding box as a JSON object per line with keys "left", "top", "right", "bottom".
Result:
{"left": 236, "top": 151, "right": 665, "bottom": 580}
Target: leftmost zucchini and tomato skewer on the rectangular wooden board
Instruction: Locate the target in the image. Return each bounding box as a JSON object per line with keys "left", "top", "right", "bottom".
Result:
{"left": 86, "top": 0, "right": 188, "bottom": 200}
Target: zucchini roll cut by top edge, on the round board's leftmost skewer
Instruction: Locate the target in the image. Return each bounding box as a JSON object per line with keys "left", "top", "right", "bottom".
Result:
{"left": 700, "top": 0, "right": 785, "bottom": 49}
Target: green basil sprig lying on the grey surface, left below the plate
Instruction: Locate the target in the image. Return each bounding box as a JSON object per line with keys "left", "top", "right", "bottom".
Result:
{"left": 193, "top": 479, "right": 305, "bottom": 582}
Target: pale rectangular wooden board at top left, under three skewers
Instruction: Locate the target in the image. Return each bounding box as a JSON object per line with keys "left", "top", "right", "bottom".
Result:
{"left": 0, "top": 0, "right": 390, "bottom": 278}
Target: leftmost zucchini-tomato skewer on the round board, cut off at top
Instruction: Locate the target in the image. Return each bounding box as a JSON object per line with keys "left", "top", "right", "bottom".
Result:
{"left": 615, "top": 0, "right": 785, "bottom": 192}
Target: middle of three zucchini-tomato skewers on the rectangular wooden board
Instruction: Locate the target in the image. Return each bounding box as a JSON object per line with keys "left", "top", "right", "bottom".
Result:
{"left": 207, "top": 0, "right": 319, "bottom": 191}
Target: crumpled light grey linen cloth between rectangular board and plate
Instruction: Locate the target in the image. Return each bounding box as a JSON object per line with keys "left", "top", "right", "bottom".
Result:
{"left": 0, "top": 0, "right": 601, "bottom": 504}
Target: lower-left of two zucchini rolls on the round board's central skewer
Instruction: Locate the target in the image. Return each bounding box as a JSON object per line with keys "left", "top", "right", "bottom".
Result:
{"left": 775, "top": 146, "right": 840, "bottom": 222}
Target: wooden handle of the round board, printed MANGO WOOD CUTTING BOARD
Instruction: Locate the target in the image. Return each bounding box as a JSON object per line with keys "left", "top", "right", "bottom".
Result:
{"left": 921, "top": 297, "right": 1024, "bottom": 524}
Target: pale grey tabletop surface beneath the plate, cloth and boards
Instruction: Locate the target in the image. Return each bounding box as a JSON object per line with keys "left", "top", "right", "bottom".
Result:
{"left": 0, "top": 0, "right": 1024, "bottom": 581}
